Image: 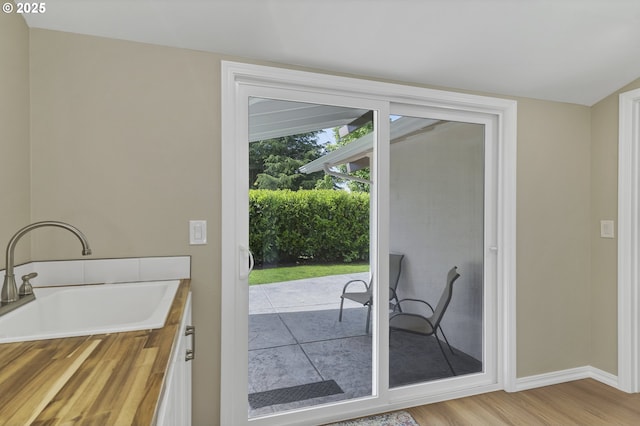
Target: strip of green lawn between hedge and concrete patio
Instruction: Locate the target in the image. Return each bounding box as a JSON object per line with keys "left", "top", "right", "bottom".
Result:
{"left": 249, "top": 263, "right": 369, "bottom": 285}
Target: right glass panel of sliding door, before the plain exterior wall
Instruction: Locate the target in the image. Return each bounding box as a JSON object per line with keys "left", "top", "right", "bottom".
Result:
{"left": 389, "top": 116, "right": 485, "bottom": 388}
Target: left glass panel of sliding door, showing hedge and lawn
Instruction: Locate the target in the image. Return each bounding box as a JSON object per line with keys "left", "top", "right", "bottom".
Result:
{"left": 247, "top": 97, "right": 374, "bottom": 418}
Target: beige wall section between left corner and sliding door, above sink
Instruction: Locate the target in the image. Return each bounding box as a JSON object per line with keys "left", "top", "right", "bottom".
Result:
{"left": 31, "top": 29, "right": 221, "bottom": 425}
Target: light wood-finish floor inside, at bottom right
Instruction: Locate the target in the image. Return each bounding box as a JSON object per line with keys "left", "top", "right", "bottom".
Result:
{"left": 407, "top": 379, "right": 640, "bottom": 426}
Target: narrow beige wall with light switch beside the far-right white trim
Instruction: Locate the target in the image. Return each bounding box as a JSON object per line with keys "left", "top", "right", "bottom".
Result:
{"left": 590, "top": 79, "right": 640, "bottom": 374}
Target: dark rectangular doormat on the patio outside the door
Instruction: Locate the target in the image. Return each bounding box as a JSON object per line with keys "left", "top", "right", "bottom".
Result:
{"left": 249, "top": 380, "right": 344, "bottom": 409}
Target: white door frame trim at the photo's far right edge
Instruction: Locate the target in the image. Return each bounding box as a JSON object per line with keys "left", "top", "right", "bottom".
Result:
{"left": 618, "top": 89, "right": 640, "bottom": 392}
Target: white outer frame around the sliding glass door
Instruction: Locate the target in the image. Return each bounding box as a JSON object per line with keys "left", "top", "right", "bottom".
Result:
{"left": 220, "top": 61, "right": 517, "bottom": 425}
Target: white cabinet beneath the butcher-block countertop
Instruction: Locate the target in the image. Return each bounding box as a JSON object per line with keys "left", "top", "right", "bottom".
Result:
{"left": 156, "top": 293, "right": 195, "bottom": 426}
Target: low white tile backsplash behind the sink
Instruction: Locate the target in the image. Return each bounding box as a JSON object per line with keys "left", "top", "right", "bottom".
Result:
{"left": 1, "top": 256, "right": 191, "bottom": 287}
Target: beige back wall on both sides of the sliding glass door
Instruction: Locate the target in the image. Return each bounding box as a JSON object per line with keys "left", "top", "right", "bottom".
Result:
{"left": 22, "top": 29, "right": 604, "bottom": 425}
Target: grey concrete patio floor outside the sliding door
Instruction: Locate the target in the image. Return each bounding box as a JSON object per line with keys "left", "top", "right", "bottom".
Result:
{"left": 248, "top": 273, "right": 482, "bottom": 417}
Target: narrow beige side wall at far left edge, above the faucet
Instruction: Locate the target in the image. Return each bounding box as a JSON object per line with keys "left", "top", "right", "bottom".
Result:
{"left": 0, "top": 13, "right": 30, "bottom": 269}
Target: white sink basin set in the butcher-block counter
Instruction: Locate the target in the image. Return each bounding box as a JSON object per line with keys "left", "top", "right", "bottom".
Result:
{"left": 0, "top": 280, "right": 180, "bottom": 343}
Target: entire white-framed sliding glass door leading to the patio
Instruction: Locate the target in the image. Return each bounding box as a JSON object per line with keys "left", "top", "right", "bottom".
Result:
{"left": 221, "top": 63, "right": 515, "bottom": 426}
